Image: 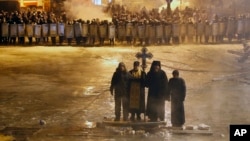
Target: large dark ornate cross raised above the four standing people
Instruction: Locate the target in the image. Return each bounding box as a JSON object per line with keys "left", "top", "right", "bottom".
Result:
{"left": 135, "top": 47, "right": 153, "bottom": 71}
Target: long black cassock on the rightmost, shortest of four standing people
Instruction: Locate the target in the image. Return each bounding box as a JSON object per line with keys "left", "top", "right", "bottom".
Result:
{"left": 168, "top": 78, "right": 186, "bottom": 126}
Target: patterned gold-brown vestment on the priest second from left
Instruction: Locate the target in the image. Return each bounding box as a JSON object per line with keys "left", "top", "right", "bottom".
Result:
{"left": 129, "top": 70, "right": 146, "bottom": 113}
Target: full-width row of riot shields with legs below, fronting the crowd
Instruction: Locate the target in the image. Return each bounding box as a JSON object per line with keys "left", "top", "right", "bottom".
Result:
{"left": 0, "top": 19, "right": 250, "bottom": 46}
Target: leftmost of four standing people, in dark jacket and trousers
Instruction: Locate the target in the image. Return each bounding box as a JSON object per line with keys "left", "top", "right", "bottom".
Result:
{"left": 110, "top": 62, "right": 130, "bottom": 121}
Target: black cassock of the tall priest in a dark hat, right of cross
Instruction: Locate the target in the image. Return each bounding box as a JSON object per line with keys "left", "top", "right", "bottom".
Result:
{"left": 146, "top": 70, "right": 168, "bottom": 121}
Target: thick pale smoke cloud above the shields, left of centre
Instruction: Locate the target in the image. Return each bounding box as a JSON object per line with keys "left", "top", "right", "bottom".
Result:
{"left": 64, "top": 0, "right": 110, "bottom": 20}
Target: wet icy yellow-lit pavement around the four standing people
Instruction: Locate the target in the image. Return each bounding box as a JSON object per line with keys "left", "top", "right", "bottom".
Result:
{"left": 0, "top": 44, "right": 250, "bottom": 141}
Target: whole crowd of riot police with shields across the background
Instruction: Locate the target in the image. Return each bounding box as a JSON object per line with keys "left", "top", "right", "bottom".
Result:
{"left": 0, "top": 4, "right": 250, "bottom": 46}
